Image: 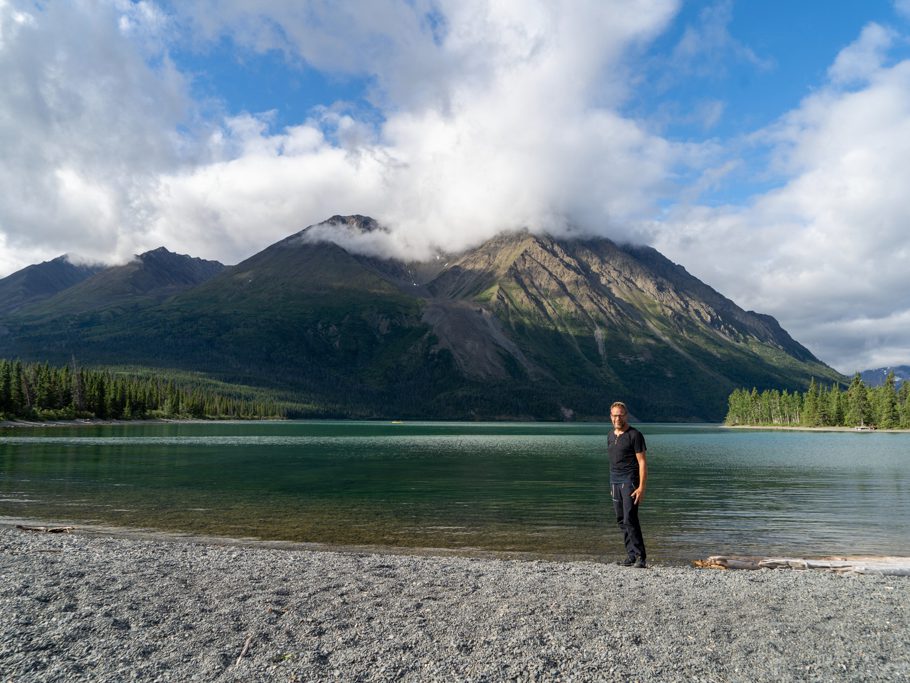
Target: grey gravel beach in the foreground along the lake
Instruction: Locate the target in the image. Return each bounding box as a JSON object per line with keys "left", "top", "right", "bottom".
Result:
{"left": 0, "top": 527, "right": 910, "bottom": 681}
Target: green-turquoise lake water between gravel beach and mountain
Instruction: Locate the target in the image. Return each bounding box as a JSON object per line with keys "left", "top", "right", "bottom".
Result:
{"left": 0, "top": 422, "right": 910, "bottom": 563}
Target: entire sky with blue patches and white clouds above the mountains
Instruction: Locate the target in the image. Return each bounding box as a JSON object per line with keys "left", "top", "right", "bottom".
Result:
{"left": 0, "top": 0, "right": 910, "bottom": 373}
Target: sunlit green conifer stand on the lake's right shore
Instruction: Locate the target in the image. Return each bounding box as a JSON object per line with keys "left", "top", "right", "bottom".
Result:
{"left": 725, "top": 372, "right": 910, "bottom": 429}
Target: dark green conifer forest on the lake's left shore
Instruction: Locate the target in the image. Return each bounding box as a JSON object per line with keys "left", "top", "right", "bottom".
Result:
{"left": 0, "top": 359, "right": 288, "bottom": 420}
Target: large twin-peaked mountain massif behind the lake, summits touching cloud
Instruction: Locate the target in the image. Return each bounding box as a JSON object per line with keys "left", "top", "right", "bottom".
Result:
{"left": 0, "top": 216, "right": 844, "bottom": 420}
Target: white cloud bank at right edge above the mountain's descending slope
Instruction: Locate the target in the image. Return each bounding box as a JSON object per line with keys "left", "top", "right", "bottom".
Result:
{"left": 655, "top": 25, "right": 910, "bottom": 373}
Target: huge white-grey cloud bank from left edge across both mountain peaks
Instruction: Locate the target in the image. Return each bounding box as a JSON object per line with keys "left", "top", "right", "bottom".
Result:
{"left": 0, "top": 0, "right": 692, "bottom": 272}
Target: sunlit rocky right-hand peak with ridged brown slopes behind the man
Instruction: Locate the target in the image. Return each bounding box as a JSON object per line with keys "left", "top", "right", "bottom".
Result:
{"left": 420, "top": 234, "right": 836, "bottom": 419}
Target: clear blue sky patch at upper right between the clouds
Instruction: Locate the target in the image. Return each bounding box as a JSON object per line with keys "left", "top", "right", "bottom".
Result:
{"left": 633, "top": 0, "right": 910, "bottom": 203}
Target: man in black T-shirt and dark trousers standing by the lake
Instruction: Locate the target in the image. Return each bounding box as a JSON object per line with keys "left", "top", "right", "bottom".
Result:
{"left": 607, "top": 401, "right": 648, "bottom": 569}
